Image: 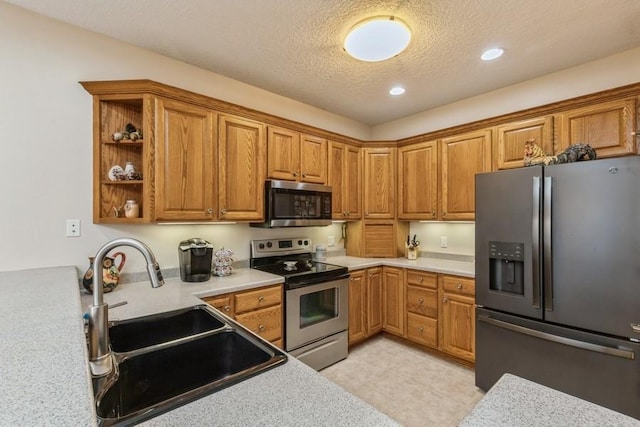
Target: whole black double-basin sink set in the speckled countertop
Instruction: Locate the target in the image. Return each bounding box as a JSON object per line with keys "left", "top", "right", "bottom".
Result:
{"left": 94, "top": 305, "right": 287, "bottom": 426}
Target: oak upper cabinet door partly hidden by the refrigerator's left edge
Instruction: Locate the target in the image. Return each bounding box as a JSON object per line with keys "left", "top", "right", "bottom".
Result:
{"left": 440, "top": 129, "right": 492, "bottom": 220}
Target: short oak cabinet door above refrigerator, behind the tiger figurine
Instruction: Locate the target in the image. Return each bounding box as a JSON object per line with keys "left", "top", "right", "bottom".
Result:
{"left": 493, "top": 116, "right": 553, "bottom": 170}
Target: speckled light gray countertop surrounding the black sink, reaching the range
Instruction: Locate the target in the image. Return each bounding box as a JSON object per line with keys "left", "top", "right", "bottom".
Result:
{"left": 0, "top": 267, "right": 398, "bottom": 426}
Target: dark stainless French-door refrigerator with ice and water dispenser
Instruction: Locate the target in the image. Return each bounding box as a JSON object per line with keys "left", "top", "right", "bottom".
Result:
{"left": 475, "top": 156, "right": 640, "bottom": 419}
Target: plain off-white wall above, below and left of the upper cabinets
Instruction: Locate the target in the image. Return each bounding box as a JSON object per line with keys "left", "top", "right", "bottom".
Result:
{"left": 0, "top": 2, "right": 640, "bottom": 273}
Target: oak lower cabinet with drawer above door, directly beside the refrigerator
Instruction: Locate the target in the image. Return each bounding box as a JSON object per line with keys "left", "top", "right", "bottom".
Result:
{"left": 439, "top": 275, "right": 476, "bottom": 362}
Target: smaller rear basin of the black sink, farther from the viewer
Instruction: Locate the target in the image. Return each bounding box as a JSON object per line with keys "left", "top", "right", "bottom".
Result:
{"left": 109, "top": 305, "right": 224, "bottom": 353}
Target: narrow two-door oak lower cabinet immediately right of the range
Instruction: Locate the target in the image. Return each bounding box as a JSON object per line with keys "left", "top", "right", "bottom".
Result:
{"left": 349, "top": 267, "right": 382, "bottom": 345}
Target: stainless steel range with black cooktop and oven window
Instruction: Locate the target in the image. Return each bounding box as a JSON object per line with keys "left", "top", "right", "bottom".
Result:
{"left": 250, "top": 237, "right": 349, "bottom": 370}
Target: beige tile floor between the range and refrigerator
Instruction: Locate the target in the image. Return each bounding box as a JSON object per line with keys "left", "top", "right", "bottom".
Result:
{"left": 320, "top": 335, "right": 483, "bottom": 427}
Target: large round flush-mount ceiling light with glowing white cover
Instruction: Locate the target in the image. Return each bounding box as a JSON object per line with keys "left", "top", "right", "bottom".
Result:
{"left": 344, "top": 16, "right": 411, "bottom": 62}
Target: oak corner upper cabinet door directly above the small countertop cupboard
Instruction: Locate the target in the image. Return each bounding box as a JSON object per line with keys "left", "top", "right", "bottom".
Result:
{"left": 362, "top": 147, "right": 396, "bottom": 219}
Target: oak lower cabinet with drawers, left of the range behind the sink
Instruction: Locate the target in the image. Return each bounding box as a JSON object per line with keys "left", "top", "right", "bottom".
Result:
{"left": 203, "top": 285, "right": 284, "bottom": 349}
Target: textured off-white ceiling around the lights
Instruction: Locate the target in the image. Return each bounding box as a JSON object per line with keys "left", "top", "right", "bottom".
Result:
{"left": 7, "top": 0, "right": 640, "bottom": 125}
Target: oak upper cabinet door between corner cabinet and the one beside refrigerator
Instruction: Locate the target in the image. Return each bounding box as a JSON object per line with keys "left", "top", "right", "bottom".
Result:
{"left": 398, "top": 141, "right": 438, "bottom": 220}
